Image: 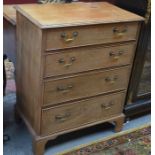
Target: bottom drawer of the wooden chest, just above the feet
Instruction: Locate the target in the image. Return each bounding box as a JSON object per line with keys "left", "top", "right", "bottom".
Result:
{"left": 41, "top": 92, "right": 125, "bottom": 134}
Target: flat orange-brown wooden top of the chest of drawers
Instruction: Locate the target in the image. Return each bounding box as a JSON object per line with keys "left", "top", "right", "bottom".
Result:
{"left": 16, "top": 2, "right": 143, "bottom": 28}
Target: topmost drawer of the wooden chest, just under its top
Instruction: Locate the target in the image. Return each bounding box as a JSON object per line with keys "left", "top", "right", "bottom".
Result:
{"left": 45, "top": 22, "right": 139, "bottom": 51}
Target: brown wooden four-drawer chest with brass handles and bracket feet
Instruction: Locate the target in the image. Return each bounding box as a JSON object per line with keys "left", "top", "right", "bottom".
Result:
{"left": 16, "top": 3, "right": 143, "bottom": 155}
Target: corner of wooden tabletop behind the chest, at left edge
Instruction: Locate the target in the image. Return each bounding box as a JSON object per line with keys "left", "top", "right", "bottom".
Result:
{"left": 3, "top": 5, "right": 16, "bottom": 25}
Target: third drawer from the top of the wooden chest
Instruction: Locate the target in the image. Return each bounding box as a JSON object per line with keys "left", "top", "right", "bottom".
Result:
{"left": 43, "top": 66, "right": 130, "bottom": 105}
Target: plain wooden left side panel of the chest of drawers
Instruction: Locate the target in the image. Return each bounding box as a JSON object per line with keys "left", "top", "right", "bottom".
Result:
{"left": 16, "top": 12, "right": 42, "bottom": 133}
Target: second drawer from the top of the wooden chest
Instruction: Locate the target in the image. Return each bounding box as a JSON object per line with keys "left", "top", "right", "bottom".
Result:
{"left": 44, "top": 43, "right": 135, "bottom": 77}
